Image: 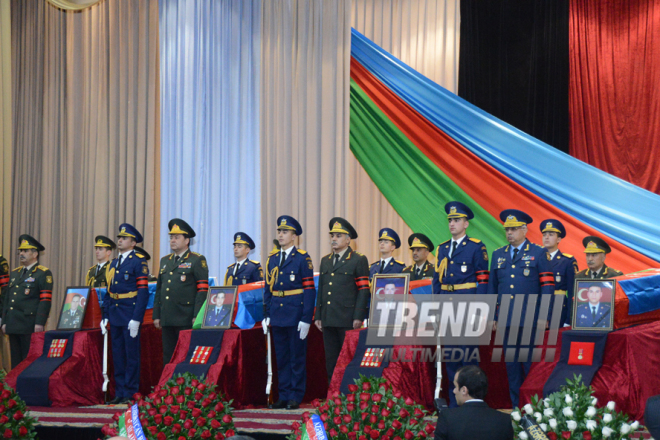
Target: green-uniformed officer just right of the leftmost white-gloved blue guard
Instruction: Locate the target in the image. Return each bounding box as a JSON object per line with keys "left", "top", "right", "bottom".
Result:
{"left": 153, "top": 218, "right": 209, "bottom": 366}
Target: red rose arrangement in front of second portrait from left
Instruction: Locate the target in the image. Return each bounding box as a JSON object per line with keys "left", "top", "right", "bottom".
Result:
{"left": 102, "top": 373, "right": 236, "bottom": 440}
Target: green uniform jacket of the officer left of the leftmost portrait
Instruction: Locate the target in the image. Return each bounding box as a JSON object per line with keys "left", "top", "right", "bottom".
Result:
{"left": 2, "top": 263, "right": 53, "bottom": 335}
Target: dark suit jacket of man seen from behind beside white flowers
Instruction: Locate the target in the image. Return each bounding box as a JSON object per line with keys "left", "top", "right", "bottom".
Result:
{"left": 435, "top": 402, "right": 513, "bottom": 440}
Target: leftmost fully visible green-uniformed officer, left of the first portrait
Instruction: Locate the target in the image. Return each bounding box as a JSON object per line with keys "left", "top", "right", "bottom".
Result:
{"left": 2, "top": 234, "right": 53, "bottom": 368}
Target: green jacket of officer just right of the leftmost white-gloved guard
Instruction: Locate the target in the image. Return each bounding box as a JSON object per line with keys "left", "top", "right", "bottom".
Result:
{"left": 154, "top": 249, "right": 209, "bottom": 327}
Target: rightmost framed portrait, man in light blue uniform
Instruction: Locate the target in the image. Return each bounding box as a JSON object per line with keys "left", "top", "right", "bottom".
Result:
{"left": 573, "top": 279, "right": 616, "bottom": 332}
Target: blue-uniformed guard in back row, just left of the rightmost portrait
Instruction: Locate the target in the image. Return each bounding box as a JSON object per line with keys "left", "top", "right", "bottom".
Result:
{"left": 539, "top": 218, "right": 578, "bottom": 326}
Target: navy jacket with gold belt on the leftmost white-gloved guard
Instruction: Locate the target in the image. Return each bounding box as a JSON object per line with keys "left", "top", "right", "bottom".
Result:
{"left": 103, "top": 251, "right": 149, "bottom": 326}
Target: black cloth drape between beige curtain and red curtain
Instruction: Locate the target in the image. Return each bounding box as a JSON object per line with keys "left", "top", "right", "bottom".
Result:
{"left": 458, "top": 0, "right": 569, "bottom": 153}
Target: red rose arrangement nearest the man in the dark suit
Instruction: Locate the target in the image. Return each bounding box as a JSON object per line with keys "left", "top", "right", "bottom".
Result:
{"left": 288, "top": 375, "right": 435, "bottom": 440}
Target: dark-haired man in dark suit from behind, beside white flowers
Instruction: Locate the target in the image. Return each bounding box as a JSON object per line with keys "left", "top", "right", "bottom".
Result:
{"left": 435, "top": 365, "right": 513, "bottom": 440}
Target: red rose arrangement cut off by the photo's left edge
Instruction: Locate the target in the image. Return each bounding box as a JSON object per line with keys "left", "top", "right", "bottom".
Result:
{"left": 0, "top": 370, "right": 37, "bottom": 439}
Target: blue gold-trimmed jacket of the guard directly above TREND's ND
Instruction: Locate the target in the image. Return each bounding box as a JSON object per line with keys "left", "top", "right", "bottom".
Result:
{"left": 433, "top": 235, "right": 488, "bottom": 294}
